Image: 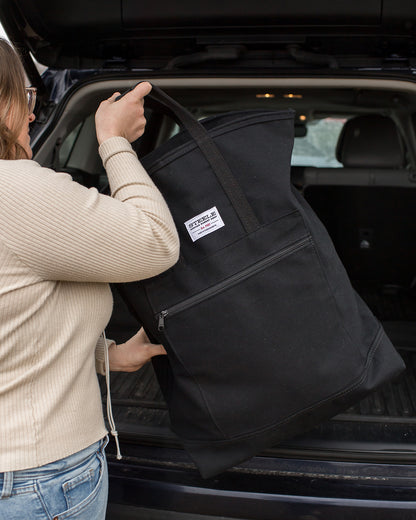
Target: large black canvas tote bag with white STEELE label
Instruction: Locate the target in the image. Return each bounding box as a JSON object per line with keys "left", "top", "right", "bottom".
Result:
{"left": 116, "top": 83, "right": 404, "bottom": 477}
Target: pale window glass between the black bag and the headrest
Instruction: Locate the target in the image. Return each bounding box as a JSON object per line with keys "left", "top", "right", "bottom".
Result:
{"left": 292, "top": 117, "right": 347, "bottom": 168}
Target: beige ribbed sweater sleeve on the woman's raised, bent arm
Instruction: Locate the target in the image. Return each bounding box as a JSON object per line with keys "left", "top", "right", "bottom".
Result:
{"left": 0, "top": 137, "right": 179, "bottom": 282}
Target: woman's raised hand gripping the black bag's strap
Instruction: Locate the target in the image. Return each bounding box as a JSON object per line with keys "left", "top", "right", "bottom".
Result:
{"left": 95, "top": 81, "right": 152, "bottom": 144}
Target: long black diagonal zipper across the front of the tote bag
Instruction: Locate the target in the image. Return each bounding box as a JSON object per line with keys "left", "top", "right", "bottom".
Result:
{"left": 156, "top": 236, "right": 311, "bottom": 332}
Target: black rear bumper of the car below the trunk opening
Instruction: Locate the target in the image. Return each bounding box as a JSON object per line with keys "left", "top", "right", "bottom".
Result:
{"left": 107, "top": 447, "right": 416, "bottom": 520}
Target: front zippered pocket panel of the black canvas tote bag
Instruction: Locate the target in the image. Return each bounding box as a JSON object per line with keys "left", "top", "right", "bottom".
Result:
{"left": 149, "top": 230, "right": 357, "bottom": 439}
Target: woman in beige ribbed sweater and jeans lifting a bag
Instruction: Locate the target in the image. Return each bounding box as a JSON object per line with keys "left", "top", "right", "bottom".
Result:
{"left": 0, "top": 40, "right": 179, "bottom": 520}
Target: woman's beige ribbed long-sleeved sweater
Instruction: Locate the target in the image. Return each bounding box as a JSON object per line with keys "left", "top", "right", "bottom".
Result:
{"left": 0, "top": 137, "right": 179, "bottom": 472}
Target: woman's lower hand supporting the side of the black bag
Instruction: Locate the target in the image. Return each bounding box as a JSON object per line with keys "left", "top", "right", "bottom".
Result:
{"left": 108, "top": 328, "right": 166, "bottom": 372}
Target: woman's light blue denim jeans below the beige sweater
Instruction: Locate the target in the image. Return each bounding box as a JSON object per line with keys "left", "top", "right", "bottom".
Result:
{"left": 0, "top": 438, "right": 108, "bottom": 520}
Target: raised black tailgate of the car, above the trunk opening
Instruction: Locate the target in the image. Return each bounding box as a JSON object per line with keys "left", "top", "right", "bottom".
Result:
{"left": 0, "top": 0, "right": 416, "bottom": 70}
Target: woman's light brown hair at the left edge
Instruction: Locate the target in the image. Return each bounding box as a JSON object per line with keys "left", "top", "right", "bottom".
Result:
{"left": 0, "top": 38, "right": 28, "bottom": 159}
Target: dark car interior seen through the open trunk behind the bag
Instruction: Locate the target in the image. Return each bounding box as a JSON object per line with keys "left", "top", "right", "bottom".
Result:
{"left": 34, "top": 75, "right": 416, "bottom": 468}
